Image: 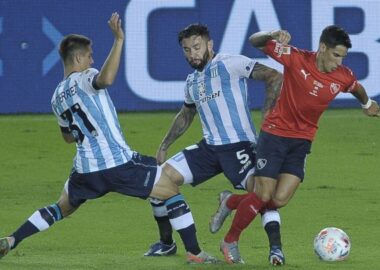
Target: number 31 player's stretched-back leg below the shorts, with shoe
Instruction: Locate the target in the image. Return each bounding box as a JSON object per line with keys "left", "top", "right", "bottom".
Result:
{"left": 0, "top": 182, "right": 77, "bottom": 258}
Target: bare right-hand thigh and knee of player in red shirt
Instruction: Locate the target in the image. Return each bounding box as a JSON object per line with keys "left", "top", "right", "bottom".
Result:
{"left": 273, "top": 173, "right": 301, "bottom": 207}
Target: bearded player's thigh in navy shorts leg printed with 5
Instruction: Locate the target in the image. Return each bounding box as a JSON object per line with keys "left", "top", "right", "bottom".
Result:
{"left": 216, "top": 142, "right": 255, "bottom": 189}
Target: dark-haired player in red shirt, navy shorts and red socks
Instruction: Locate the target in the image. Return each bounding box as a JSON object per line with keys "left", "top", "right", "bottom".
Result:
{"left": 209, "top": 25, "right": 379, "bottom": 264}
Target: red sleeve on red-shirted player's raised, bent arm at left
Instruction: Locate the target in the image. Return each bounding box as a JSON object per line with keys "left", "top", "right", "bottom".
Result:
{"left": 264, "top": 40, "right": 298, "bottom": 66}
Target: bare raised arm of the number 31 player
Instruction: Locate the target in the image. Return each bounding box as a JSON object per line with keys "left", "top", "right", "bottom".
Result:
{"left": 96, "top": 12, "right": 124, "bottom": 89}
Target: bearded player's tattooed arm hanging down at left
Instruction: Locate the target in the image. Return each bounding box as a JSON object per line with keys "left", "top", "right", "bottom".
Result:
{"left": 156, "top": 105, "right": 196, "bottom": 164}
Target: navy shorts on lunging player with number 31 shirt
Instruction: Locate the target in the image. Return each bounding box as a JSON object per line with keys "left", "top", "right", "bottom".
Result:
{"left": 67, "top": 153, "right": 158, "bottom": 207}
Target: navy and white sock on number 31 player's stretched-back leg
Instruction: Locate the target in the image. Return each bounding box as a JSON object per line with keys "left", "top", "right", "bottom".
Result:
{"left": 12, "top": 204, "right": 63, "bottom": 249}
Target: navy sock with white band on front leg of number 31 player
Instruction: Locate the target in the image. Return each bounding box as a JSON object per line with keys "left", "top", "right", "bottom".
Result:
{"left": 165, "top": 194, "right": 201, "bottom": 255}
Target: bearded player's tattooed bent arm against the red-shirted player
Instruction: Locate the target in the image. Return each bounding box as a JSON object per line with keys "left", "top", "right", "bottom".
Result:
{"left": 251, "top": 63, "right": 283, "bottom": 118}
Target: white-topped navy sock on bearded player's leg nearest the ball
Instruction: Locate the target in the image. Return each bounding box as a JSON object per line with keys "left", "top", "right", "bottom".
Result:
{"left": 261, "top": 210, "right": 282, "bottom": 248}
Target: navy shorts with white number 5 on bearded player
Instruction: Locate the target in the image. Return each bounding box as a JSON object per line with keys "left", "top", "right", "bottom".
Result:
{"left": 173, "top": 140, "right": 255, "bottom": 189}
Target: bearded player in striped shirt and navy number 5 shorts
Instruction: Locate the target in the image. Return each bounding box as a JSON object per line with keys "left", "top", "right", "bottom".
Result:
{"left": 145, "top": 24, "right": 284, "bottom": 264}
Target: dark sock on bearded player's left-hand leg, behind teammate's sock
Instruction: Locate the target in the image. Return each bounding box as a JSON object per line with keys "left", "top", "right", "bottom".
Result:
{"left": 150, "top": 199, "right": 173, "bottom": 245}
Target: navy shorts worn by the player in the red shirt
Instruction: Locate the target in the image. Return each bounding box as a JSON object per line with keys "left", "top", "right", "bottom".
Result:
{"left": 255, "top": 131, "right": 311, "bottom": 181}
